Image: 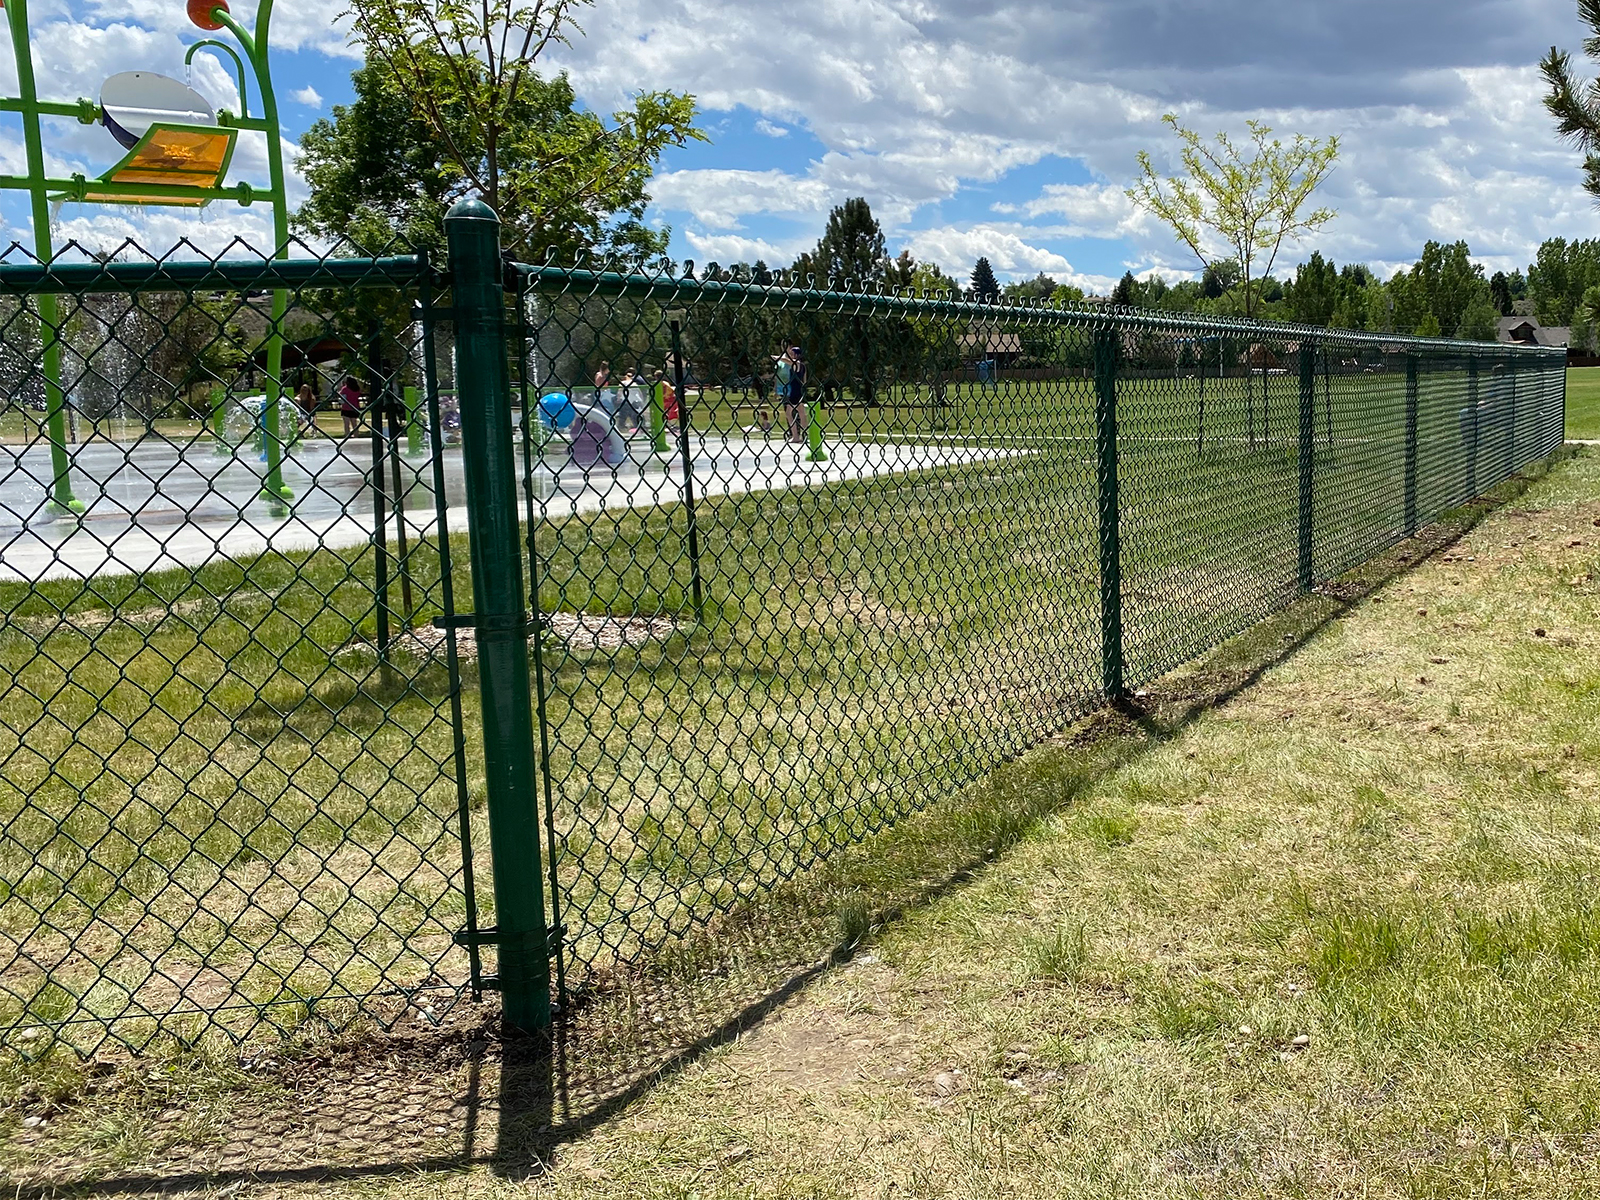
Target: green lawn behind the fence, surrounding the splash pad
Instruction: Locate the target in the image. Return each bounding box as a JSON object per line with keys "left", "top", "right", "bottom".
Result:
{"left": 0, "top": 361, "right": 1561, "bottom": 1043}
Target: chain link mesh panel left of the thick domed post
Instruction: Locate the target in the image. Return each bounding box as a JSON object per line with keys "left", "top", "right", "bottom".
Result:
{"left": 0, "top": 235, "right": 467, "bottom": 1054}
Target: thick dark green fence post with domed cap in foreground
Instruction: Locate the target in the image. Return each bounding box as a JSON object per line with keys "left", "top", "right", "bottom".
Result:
{"left": 445, "top": 198, "right": 550, "bottom": 1032}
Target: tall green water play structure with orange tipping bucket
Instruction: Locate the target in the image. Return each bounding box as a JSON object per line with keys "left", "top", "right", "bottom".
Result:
{"left": 0, "top": 0, "right": 293, "bottom": 515}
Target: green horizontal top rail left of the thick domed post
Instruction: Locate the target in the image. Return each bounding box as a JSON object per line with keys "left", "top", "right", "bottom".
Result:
{"left": 0, "top": 254, "right": 429, "bottom": 296}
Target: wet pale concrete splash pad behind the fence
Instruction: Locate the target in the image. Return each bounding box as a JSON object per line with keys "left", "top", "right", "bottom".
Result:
{"left": 0, "top": 434, "right": 1026, "bottom": 581}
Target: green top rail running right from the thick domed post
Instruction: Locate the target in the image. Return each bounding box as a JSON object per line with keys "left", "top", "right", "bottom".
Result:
{"left": 507, "top": 262, "right": 1566, "bottom": 355}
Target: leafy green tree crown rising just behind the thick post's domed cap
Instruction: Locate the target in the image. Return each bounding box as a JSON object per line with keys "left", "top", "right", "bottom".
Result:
{"left": 340, "top": 0, "right": 704, "bottom": 258}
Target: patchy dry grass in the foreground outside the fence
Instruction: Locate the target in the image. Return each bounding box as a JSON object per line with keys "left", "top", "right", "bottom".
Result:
{"left": 5, "top": 453, "right": 1600, "bottom": 1200}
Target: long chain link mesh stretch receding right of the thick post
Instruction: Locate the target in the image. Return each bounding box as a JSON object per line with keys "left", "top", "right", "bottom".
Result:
{"left": 515, "top": 267, "right": 1565, "bottom": 998}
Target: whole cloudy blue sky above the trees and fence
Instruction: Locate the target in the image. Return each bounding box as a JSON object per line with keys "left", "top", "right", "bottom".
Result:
{"left": 0, "top": 0, "right": 1600, "bottom": 290}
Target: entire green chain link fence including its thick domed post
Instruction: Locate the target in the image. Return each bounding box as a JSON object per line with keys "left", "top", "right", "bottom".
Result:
{"left": 0, "top": 203, "right": 1565, "bottom": 1054}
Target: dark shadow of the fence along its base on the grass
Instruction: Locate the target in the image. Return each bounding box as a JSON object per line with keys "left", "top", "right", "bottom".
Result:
{"left": 16, "top": 451, "right": 1571, "bottom": 1200}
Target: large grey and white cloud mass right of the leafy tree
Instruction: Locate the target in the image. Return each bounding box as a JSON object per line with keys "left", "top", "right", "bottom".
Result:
{"left": 553, "top": 0, "right": 1600, "bottom": 281}
